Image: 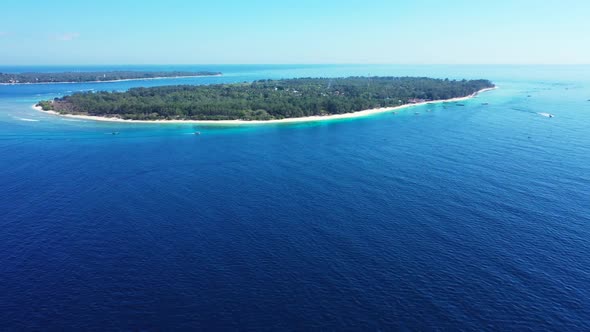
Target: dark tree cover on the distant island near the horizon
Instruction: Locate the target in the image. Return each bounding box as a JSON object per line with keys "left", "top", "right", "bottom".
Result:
{"left": 0, "top": 71, "right": 221, "bottom": 84}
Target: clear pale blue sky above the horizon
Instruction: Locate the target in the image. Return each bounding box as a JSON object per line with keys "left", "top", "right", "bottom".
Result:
{"left": 0, "top": 0, "right": 590, "bottom": 65}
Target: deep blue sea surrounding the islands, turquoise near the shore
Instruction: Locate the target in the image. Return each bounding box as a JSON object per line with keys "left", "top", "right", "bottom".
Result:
{"left": 0, "top": 65, "right": 590, "bottom": 331}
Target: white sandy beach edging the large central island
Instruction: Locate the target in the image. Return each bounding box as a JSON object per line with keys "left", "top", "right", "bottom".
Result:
{"left": 33, "top": 86, "right": 498, "bottom": 125}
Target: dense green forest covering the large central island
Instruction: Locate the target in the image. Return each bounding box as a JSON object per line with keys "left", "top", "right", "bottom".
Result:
{"left": 38, "top": 77, "right": 494, "bottom": 120}
